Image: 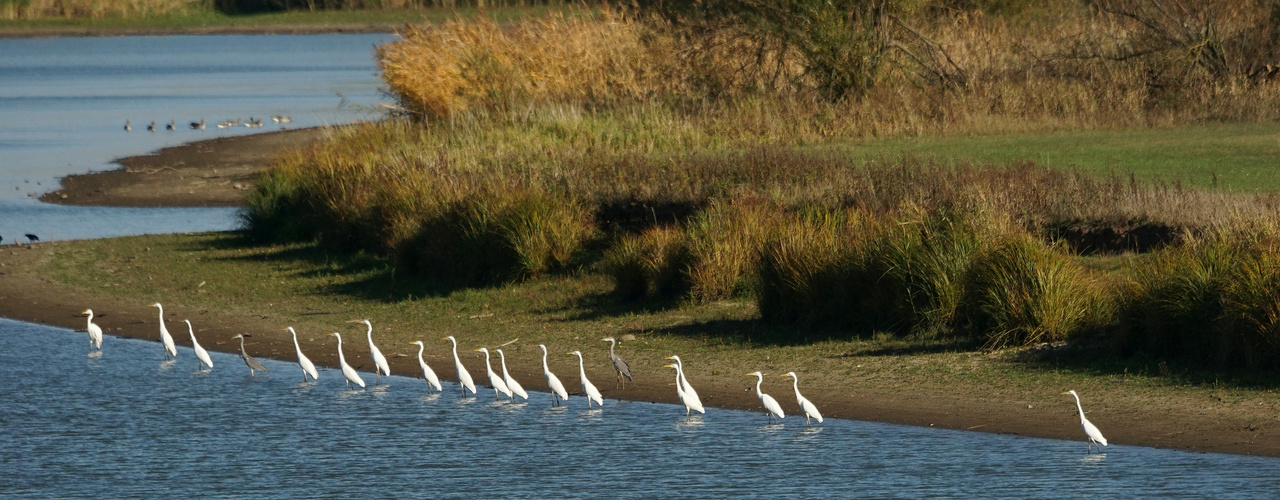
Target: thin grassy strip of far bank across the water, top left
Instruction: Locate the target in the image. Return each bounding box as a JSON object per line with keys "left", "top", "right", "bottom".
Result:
{"left": 0, "top": 6, "right": 565, "bottom": 33}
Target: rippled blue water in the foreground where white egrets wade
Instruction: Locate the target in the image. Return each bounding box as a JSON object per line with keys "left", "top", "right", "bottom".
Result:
{"left": 0, "top": 320, "right": 1280, "bottom": 497}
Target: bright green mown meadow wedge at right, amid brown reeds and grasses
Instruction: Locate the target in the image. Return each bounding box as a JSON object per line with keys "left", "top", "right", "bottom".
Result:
{"left": 837, "top": 123, "right": 1280, "bottom": 192}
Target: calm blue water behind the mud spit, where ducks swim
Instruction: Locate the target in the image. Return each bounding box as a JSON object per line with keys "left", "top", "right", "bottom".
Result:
{"left": 0, "top": 35, "right": 392, "bottom": 242}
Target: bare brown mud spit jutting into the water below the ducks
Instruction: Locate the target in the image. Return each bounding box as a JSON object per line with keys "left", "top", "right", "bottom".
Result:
{"left": 40, "top": 128, "right": 325, "bottom": 207}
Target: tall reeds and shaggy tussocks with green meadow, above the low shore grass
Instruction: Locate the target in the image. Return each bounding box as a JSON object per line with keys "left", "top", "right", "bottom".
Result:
{"left": 244, "top": 3, "right": 1280, "bottom": 370}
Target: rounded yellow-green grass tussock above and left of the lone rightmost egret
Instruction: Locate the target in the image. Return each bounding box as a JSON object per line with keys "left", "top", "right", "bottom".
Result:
{"left": 966, "top": 235, "right": 1103, "bottom": 348}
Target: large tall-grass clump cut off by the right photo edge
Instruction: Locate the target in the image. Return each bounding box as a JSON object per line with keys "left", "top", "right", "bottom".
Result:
{"left": 1121, "top": 223, "right": 1280, "bottom": 368}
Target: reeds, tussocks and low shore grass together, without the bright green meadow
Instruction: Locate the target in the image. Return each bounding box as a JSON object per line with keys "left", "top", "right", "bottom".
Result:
{"left": 4, "top": 0, "right": 1280, "bottom": 455}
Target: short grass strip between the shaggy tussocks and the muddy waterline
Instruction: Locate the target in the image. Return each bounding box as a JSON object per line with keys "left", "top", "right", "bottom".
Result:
{"left": 36, "top": 234, "right": 1280, "bottom": 416}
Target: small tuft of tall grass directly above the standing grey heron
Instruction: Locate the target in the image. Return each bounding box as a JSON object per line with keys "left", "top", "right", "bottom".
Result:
{"left": 602, "top": 226, "right": 689, "bottom": 299}
